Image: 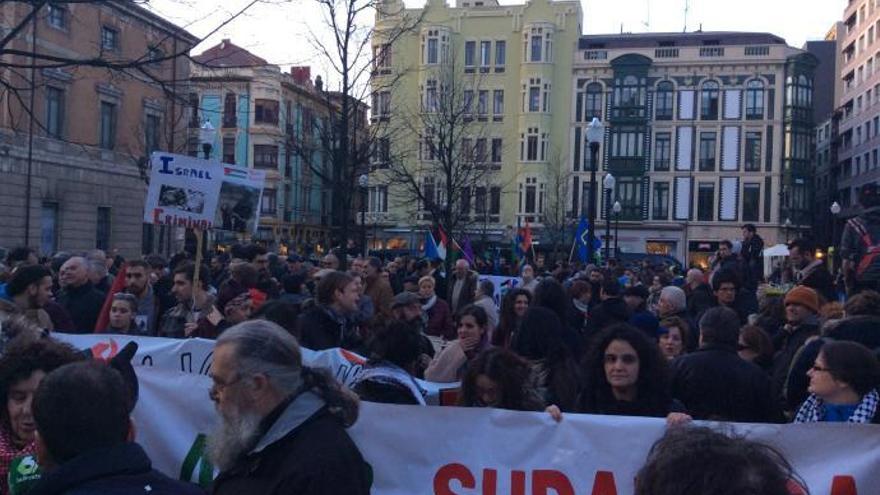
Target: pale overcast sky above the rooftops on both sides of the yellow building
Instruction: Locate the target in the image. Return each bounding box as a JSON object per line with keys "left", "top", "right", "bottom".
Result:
{"left": 149, "top": 0, "right": 847, "bottom": 78}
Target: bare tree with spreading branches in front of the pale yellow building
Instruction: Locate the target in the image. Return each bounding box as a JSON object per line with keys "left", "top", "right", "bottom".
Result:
{"left": 383, "top": 57, "right": 502, "bottom": 276}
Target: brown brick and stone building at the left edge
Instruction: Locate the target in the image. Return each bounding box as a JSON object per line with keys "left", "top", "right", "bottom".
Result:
{"left": 0, "top": 2, "right": 197, "bottom": 256}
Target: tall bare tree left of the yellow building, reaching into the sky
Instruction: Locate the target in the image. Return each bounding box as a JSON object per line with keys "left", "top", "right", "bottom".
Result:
{"left": 287, "top": 0, "right": 421, "bottom": 252}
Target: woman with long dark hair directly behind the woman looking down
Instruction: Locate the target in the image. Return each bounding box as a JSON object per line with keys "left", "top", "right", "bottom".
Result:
{"left": 511, "top": 307, "right": 580, "bottom": 411}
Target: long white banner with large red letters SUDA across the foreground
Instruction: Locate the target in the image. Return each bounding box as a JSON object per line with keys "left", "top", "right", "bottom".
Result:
{"left": 55, "top": 335, "right": 880, "bottom": 495}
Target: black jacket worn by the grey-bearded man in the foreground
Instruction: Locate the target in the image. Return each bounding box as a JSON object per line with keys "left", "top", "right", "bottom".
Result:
{"left": 212, "top": 394, "right": 371, "bottom": 495}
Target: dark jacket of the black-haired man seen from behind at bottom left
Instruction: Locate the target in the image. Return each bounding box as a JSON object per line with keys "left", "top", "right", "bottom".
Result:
{"left": 28, "top": 443, "right": 205, "bottom": 495}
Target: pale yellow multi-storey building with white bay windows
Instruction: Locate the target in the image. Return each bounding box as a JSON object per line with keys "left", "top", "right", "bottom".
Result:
{"left": 365, "top": 0, "right": 583, "bottom": 249}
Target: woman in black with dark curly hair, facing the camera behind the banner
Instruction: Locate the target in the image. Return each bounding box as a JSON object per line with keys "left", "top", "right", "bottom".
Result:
{"left": 580, "top": 324, "right": 690, "bottom": 423}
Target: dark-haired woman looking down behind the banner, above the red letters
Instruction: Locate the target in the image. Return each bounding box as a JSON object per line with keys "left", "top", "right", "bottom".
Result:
{"left": 458, "top": 348, "right": 544, "bottom": 411}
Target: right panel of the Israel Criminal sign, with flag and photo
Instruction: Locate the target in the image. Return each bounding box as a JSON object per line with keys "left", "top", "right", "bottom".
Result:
{"left": 215, "top": 165, "right": 266, "bottom": 233}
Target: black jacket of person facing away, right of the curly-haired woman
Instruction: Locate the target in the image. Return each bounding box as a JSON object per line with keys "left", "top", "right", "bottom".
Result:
{"left": 672, "top": 345, "right": 782, "bottom": 423}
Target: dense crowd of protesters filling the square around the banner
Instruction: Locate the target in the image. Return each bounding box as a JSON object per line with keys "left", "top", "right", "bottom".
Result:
{"left": 0, "top": 185, "right": 880, "bottom": 493}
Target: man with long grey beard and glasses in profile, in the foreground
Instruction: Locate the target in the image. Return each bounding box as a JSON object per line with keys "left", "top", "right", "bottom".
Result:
{"left": 208, "top": 320, "right": 370, "bottom": 495}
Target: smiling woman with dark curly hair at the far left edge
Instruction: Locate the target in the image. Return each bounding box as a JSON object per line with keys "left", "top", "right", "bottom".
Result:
{"left": 0, "top": 335, "right": 82, "bottom": 480}
